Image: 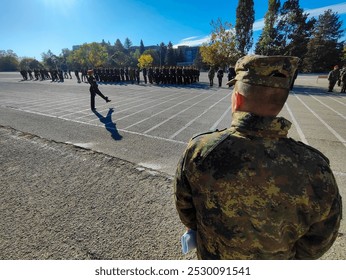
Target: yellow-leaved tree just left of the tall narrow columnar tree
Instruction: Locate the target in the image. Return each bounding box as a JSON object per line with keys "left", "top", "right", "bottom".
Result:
{"left": 200, "top": 19, "right": 241, "bottom": 67}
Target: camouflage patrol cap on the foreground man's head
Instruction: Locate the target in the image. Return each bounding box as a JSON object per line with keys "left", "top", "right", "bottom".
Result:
{"left": 227, "top": 55, "right": 299, "bottom": 89}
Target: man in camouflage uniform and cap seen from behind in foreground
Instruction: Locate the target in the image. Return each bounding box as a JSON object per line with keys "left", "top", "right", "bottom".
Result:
{"left": 174, "top": 56, "right": 342, "bottom": 259}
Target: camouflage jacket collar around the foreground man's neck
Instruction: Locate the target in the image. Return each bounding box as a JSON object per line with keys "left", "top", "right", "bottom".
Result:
{"left": 231, "top": 111, "right": 292, "bottom": 138}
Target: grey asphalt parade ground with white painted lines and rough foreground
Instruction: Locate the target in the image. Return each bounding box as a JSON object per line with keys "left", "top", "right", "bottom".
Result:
{"left": 0, "top": 72, "right": 346, "bottom": 260}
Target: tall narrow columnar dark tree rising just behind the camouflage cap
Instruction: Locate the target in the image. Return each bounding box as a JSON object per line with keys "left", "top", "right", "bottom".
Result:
{"left": 255, "top": 0, "right": 281, "bottom": 55}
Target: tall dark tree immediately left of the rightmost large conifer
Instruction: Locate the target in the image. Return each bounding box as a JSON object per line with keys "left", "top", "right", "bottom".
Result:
{"left": 278, "top": 0, "right": 316, "bottom": 59}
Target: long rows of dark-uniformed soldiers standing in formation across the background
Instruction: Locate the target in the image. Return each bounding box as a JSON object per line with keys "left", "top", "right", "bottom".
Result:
{"left": 20, "top": 66, "right": 200, "bottom": 85}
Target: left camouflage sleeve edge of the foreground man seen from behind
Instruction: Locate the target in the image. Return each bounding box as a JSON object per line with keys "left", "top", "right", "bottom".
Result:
{"left": 174, "top": 152, "right": 196, "bottom": 230}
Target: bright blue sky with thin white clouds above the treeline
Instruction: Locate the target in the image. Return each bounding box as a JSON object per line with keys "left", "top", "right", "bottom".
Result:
{"left": 0, "top": 0, "right": 346, "bottom": 60}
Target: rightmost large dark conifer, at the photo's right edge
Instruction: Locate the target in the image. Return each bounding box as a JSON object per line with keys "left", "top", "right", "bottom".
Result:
{"left": 304, "top": 10, "right": 344, "bottom": 72}
